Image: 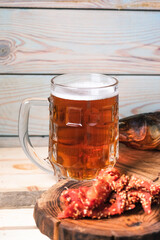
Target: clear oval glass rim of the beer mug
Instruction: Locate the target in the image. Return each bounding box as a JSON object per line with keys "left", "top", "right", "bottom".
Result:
{"left": 51, "top": 73, "right": 119, "bottom": 89}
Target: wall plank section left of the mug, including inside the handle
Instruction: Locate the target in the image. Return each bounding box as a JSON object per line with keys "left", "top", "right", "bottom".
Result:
{"left": 0, "top": 76, "right": 52, "bottom": 135}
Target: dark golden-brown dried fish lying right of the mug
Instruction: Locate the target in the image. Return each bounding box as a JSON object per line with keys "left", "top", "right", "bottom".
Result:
{"left": 119, "top": 112, "right": 160, "bottom": 150}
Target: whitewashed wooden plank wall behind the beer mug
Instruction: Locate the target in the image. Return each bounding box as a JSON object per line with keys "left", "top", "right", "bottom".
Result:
{"left": 0, "top": 0, "right": 160, "bottom": 146}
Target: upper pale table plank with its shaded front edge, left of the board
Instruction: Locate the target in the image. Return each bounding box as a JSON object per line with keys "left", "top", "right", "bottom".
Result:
{"left": 0, "top": 148, "right": 56, "bottom": 208}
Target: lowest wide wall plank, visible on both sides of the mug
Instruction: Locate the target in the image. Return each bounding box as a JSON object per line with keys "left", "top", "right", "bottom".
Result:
{"left": 0, "top": 75, "right": 160, "bottom": 139}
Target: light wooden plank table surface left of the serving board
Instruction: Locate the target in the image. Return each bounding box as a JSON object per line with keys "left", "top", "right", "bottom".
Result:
{"left": 0, "top": 148, "right": 55, "bottom": 240}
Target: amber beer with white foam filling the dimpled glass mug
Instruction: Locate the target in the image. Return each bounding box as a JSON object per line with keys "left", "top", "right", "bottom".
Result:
{"left": 49, "top": 74, "right": 118, "bottom": 180}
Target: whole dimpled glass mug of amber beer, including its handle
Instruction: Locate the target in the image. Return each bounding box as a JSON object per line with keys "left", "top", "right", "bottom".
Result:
{"left": 19, "top": 73, "right": 119, "bottom": 180}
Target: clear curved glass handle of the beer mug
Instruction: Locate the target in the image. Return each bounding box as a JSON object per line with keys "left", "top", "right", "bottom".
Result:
{"left": 18, "top": 98, "right": 53, "bottom": 174}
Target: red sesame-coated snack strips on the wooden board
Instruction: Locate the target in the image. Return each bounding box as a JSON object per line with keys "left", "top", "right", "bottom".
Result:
{"left": 58, "top": 168, "right": 160, "bottom": 219}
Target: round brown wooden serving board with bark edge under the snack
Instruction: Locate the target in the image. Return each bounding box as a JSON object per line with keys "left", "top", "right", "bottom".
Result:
{"left": 34, "top": 144, "right": 160, "bottom": 240}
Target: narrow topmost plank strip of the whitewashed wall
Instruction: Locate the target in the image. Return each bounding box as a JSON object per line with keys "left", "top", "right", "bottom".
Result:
{"left": 0, "top": 0, "right": 160, "bottom": 10}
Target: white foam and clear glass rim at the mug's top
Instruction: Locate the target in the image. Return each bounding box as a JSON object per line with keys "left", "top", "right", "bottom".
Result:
{"left": 51, "top": 74, "right": 118, "bottom": 101}
